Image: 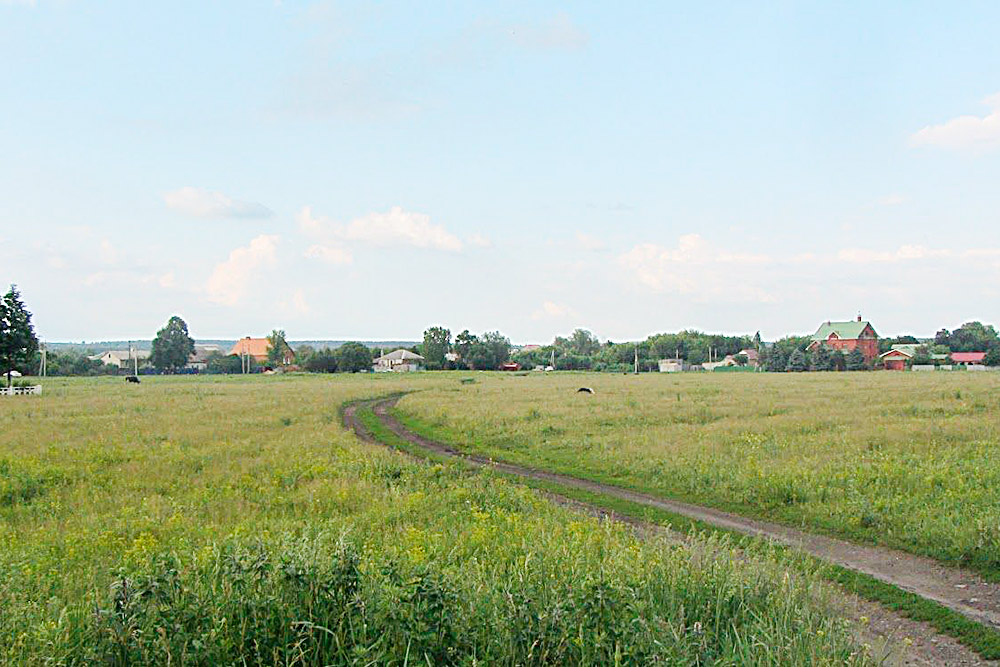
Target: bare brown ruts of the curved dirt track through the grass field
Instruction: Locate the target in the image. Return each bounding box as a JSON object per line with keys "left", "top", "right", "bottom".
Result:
{"left": 343, "top": 396, "right": 1000, "bottom": 665}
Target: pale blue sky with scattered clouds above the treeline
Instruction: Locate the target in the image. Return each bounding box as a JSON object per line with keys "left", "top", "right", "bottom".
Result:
{"left": 0, "top": 0, "right": 1000, "bottom": 343}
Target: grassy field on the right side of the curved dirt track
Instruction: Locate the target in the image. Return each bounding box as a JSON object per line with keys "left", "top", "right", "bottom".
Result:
{"left": 398, "top": 372, "right": 1000, "bottom": 578}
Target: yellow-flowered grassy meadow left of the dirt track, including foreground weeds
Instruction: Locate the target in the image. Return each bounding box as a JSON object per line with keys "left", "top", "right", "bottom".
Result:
{"left": 0, "top": 374, "right": 869, "bottom": 665}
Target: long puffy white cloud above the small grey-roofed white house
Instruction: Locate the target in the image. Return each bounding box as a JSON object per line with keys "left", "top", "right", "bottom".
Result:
{"left": 299, "top": 206, "right": 462, "bottom": 252}
